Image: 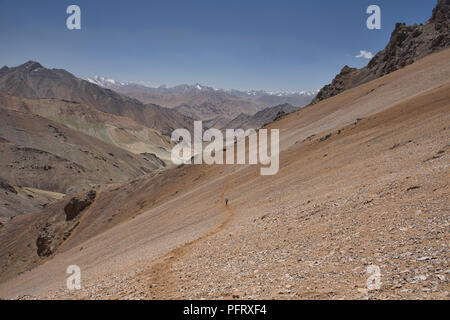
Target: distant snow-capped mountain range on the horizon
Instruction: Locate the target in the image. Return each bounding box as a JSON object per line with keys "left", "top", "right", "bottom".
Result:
{"left": 87, "top": 76, "right": 317, "bottom": 127}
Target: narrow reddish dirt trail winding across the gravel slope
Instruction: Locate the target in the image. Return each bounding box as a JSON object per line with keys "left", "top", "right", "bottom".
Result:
{"left": 138, "top": 177, "right": 236, "bottom": 299}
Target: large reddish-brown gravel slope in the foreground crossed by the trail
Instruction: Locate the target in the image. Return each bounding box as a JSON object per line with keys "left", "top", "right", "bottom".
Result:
{"left": 0, "top": 50, "right": 450, "bottom": 299}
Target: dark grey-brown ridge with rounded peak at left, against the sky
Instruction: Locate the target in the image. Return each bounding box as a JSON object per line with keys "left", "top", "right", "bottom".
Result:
{"left": 0, "top": 61, "right": 193, "bottom": 135}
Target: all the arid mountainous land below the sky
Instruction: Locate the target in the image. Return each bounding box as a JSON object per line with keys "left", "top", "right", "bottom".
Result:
{"left": 0, "top": 0, "right": 450, "bottom": 300}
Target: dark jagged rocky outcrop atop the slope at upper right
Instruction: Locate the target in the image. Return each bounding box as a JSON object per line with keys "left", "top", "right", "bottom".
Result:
{"left": 311, "top": 0, "right": 450, "bottom": 104}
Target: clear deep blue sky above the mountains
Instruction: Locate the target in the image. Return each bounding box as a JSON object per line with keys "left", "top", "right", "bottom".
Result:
{"left": 0, "top": 0, "right": 437, "bottom": 91}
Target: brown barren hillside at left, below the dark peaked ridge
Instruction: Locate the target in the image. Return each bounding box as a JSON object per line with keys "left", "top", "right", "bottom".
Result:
{"left": 0, "top": 108, "right": 164, "bottom": 216}
